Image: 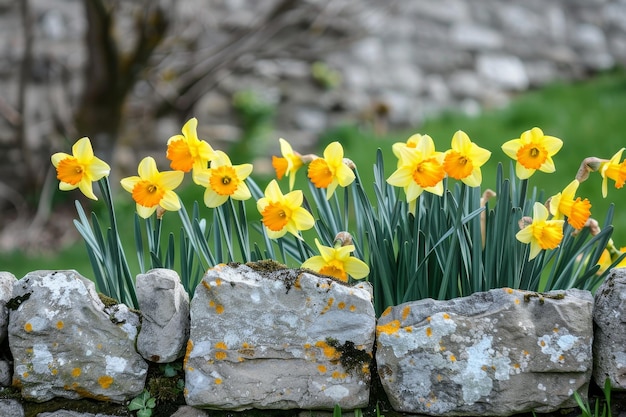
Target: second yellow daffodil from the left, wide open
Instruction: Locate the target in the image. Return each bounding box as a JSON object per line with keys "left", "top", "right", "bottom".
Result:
{"left": 121, "top": 156, "right": 185, "bottom": 219}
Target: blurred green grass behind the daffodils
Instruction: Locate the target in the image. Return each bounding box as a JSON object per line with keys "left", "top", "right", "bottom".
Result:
{"left": 0, "top": 70, "right": 626, "bottom": 278}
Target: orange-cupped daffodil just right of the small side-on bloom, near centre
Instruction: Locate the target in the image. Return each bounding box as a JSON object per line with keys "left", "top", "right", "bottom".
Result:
{"left": 308, "top": 142, "right": 355, "bottom": 199}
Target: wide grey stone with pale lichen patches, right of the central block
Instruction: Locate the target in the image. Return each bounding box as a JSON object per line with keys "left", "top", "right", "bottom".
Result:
{"left": 376, "top": 289, "right": 593, "bottom": 416}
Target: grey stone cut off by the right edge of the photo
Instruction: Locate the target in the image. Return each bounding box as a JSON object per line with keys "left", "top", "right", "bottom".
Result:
{"left": 593, "top": 268, "right": 626, "bottom": 390}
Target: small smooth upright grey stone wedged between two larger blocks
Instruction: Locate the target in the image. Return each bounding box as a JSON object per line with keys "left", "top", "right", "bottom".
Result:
{"left": 136, "top": 269, "right": 189, "bottom": 363}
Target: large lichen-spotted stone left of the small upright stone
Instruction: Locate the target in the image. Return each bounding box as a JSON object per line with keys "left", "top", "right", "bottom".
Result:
{"left": 9, "top": 271, "right": 148, "bottom": 403}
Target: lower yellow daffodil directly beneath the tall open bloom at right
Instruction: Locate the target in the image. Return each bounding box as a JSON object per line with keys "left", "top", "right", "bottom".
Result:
{"left": 515, "top": 203, "right": 564, "bottom": 260}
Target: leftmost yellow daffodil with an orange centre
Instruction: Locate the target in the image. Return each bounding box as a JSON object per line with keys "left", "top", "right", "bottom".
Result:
{"left": 51, "top": 138, "right": 111, "bottom": 200}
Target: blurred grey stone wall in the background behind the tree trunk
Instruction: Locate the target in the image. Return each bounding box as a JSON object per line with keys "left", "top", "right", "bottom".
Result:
{"left": 0, "top": 0, "right": 626, "bottom": 193}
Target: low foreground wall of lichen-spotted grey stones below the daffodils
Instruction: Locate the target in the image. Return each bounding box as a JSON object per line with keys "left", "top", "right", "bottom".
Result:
{"left": 0, "top": 261, "right": 626, "bottom": 417}
